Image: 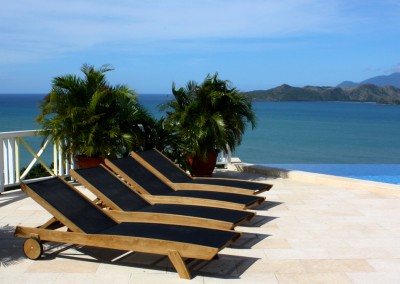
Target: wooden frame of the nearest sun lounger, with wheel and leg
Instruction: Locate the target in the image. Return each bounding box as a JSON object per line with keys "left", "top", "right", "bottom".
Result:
{"left": 15, "top": 180, "right": 241, "bottom": 279}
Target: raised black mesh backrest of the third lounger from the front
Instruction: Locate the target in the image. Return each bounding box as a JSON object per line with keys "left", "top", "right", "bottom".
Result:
{"left": 110, "top": 157, "right": 174, "bottom": 195}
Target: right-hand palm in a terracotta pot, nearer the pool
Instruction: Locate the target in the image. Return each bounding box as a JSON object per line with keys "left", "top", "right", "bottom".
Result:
{"left": 163, "top": 73, "right": 256, "bottom": 176}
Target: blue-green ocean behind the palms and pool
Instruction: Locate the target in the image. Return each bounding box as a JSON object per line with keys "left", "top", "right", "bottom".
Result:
{"left": 0, "top": 94, "right": 400, "bottom": 183}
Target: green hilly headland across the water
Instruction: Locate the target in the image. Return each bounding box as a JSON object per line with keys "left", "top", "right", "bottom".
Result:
{"left": 245, "top": 84, "right": 400, "bottom": 104}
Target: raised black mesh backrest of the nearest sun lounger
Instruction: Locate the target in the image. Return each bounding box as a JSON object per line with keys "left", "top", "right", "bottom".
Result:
{"left": 25, "top": 177, "right": 116, "bottom": 234}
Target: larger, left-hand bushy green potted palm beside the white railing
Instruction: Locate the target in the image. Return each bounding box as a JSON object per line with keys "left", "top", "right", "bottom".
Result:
{"left": 36, "top": 64, "right": 154, "bottom": 167}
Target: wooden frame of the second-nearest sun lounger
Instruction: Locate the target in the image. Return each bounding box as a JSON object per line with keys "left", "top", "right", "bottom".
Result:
{"left": 70, "top": 165, "right": 255, "bottom": 230}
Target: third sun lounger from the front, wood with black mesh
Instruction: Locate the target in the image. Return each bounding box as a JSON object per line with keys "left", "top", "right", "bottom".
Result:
{"left": 105, "top": 157, "right": 265, "bottom": 209}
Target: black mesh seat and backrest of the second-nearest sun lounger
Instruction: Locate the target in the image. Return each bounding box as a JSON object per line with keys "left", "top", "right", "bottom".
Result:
{"left": 71, "top": 166, "right": 254, "bottom": 225}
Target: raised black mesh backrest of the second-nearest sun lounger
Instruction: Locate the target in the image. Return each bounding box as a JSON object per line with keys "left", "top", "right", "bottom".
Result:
{"left": 74, "top": 166, "right": 150, "bottom": 211}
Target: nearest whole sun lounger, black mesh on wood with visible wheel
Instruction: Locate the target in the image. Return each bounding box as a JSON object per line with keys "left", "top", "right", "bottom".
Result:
{"left": 15, "top": 177, "right": 240, "bottom": 279}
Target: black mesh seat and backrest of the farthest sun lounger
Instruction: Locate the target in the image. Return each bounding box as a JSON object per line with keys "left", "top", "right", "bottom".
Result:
{"left": 137, "top": 149, "right": 272, "bottom": 194}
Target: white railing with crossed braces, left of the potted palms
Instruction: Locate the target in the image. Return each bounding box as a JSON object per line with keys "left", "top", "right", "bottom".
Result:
{"left": 0, "top": 130, "right": 73, "bottom": 193}
